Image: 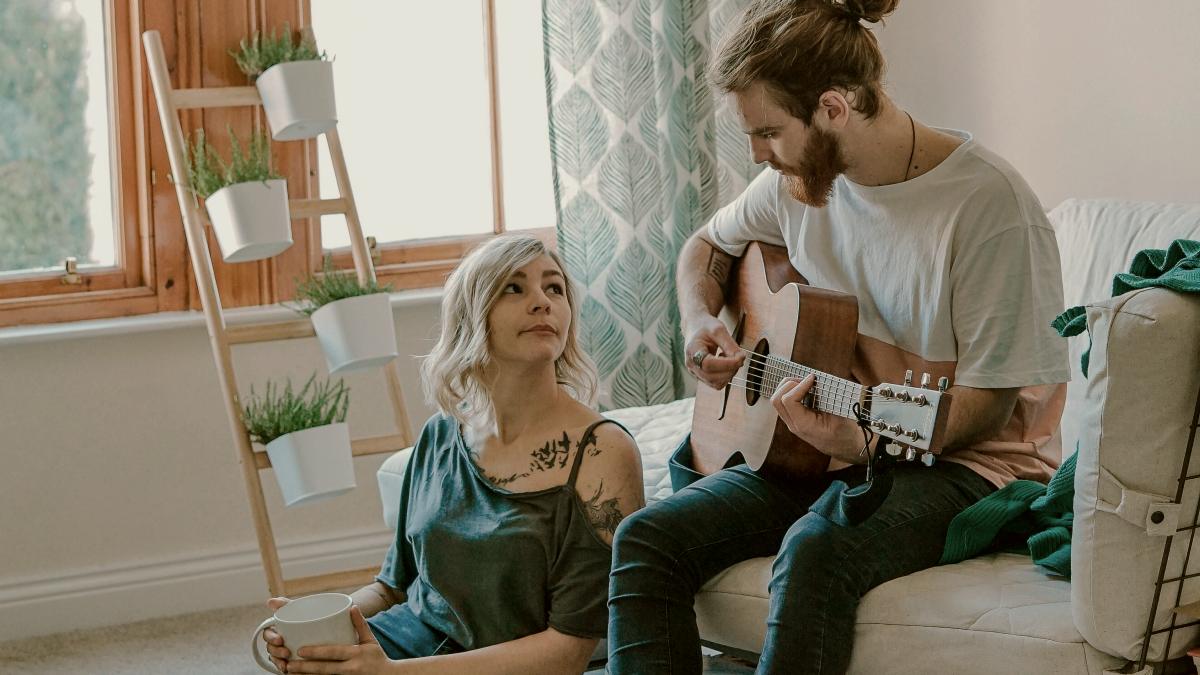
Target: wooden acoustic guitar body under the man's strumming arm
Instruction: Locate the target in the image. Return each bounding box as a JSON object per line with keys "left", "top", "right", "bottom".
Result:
{"left": 691, "top": 241, "right": 858, "bottom": 479}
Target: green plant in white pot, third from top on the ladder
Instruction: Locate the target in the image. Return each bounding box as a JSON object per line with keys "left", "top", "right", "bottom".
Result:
{"left": 293, "top": 258, "right": 397, "bottom": 374}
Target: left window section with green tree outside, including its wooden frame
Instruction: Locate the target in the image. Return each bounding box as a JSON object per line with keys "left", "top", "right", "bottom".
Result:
{"left": 0, "top": 0, "right": 157, "bottom": 325}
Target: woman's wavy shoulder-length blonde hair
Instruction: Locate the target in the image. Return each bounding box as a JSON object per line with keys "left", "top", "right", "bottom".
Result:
{"left": 421, "top": 235, "right": 596, "bottom": 424}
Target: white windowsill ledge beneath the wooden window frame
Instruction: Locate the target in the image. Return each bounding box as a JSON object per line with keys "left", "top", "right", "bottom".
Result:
{"left": 0, "top": 288, "right": 442, "bottom": 347}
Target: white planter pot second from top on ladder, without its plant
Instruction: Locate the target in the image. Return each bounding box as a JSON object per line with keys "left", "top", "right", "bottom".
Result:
{"left": 204, "top": 178, "right": 292, "bottom": 263}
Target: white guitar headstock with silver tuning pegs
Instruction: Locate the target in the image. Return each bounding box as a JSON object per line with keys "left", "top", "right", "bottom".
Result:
{"left": 870, "top": 370, "right": 950, "bottom": 466}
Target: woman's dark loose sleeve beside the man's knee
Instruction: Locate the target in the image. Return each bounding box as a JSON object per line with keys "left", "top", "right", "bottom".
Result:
{"left": 548, "top": 530, "right": 612, "bottom": 639}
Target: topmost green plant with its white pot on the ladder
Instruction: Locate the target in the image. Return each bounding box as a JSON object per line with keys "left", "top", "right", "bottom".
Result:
{"left": 229, "top": 24, "right": 337, "bottom": 141}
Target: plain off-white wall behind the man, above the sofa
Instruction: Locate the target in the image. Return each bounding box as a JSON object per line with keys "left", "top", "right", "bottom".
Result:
{"left": 877, "top": 0, "right": 1200, "bottom": 208}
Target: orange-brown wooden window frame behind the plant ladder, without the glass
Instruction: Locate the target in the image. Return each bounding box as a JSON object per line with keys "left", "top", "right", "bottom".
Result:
{"left": 0, "top": 0, "right": 556, "bottom": 328}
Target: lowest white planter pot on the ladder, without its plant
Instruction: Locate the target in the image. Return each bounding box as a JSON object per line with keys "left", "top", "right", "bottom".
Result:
{"left": 266, "top": 422, "right": 354, "bottom": 507}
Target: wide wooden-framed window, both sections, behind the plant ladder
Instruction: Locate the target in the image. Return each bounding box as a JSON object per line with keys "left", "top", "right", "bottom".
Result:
{"left": 0, "top": 0, "right": 554, "bottom": 327}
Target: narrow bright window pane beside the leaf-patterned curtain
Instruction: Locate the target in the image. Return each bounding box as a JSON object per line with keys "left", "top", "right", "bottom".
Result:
{"left": 496, "top": 0, "right": 554, "bottom": 229}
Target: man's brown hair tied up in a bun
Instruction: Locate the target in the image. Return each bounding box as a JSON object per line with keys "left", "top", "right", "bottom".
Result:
{"left": 708, "top": 0, "right": 900, "bottom": 125}
